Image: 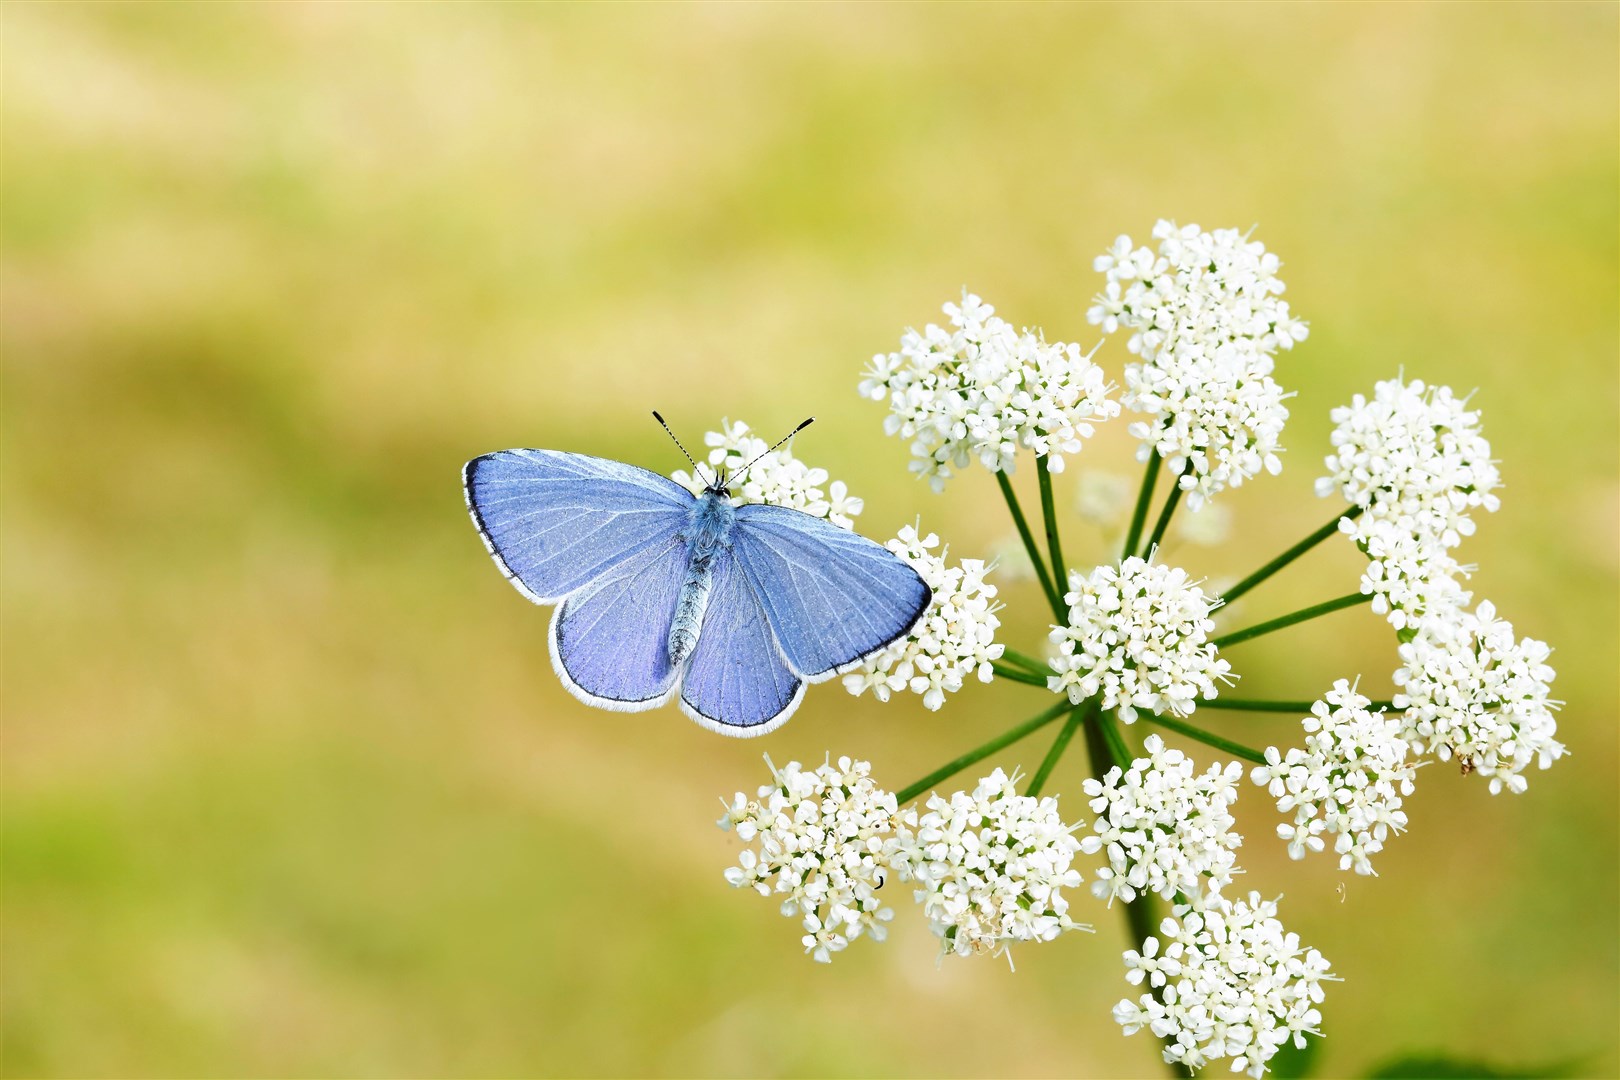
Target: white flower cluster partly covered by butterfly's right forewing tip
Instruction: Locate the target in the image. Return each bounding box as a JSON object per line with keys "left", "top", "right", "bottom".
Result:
{"left": 844, "top": 525, "right": 1006, "bottom": 709}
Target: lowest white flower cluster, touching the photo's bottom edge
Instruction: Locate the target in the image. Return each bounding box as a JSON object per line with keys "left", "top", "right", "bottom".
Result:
{"left": 1113, "top": 892, "right": 1333, "bottom": 1080}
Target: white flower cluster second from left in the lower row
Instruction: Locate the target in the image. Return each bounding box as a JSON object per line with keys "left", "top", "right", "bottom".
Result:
{"left": 894, "top": 769, "right": 1090, "bottom": 960}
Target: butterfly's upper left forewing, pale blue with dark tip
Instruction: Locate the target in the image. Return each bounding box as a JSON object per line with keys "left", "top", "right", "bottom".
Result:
{"left": 462, "top": 450, "right": 692, "bottom": 604}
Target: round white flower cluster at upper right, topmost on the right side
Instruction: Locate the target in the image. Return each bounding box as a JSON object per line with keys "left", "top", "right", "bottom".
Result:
{"left": 1315, "top": 379, "right": 1500, "bottom": 547}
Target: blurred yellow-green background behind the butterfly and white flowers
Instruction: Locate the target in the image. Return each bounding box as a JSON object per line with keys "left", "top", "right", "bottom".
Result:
{"left": 0, "top": 3, "right": 1620, "bottom": 1075}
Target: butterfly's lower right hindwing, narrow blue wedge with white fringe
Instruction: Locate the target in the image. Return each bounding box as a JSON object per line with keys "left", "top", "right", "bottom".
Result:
{"left": 680, "top": 555, "right": 805, "bottom": 735}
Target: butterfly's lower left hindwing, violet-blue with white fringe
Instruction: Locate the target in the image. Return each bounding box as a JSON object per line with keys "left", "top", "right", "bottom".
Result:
{"left": 551, "top": 536, "right": 687, "bottom": 712}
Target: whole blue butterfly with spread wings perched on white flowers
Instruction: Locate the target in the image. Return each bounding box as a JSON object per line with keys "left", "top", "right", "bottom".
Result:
{"left": 462, "top": 413, "right": 933, "bottom": 735}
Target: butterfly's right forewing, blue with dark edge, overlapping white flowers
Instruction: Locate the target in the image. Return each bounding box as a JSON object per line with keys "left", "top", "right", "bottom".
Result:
{"left": 731, "top": 504, "right": 933, "bottom": 682}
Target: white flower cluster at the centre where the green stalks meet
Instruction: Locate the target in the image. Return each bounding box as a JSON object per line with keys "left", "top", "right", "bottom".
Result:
{"left": 1047, "top": 555, "right": 1233, "bottom": 724}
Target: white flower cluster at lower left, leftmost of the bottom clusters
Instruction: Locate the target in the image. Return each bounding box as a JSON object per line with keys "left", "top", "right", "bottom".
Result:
{"left": 718, "top": 758, "right": 901, "bottom": 963}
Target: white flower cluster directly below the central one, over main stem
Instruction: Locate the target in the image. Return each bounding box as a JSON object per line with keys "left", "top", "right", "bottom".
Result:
{"left": 1081, "top": 735, "right": 1243, "bottom": 904}
